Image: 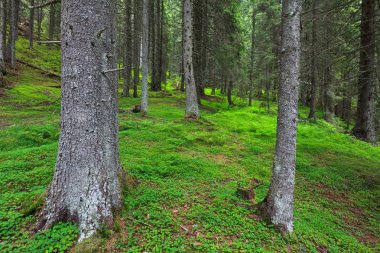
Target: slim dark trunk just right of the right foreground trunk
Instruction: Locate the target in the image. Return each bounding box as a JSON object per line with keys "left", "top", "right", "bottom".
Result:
{"left": 309, "top": 0, "right": 317, "bottom": 120}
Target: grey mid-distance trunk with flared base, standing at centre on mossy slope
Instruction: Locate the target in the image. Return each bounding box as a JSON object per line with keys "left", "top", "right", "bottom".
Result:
{"left": 183, "top": 0, "right": 200, "bottom": 119}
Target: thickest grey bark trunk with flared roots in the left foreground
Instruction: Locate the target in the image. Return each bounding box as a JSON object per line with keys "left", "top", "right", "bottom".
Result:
{"left": 38, "top": 0, "right": 122, "bottom": 241}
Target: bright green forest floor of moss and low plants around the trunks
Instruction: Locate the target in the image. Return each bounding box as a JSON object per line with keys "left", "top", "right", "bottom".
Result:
{"left": 0, "top": 40, "right": 380, "bottom": 252}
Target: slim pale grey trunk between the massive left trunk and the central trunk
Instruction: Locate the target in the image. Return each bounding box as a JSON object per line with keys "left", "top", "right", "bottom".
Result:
{"left": 141, "top": 0, "right": 150, "bottom": 115}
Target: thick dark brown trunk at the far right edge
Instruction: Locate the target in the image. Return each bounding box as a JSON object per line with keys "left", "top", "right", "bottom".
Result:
{"left": 353, "top": 0, "right": 376, "bottom": 143}
